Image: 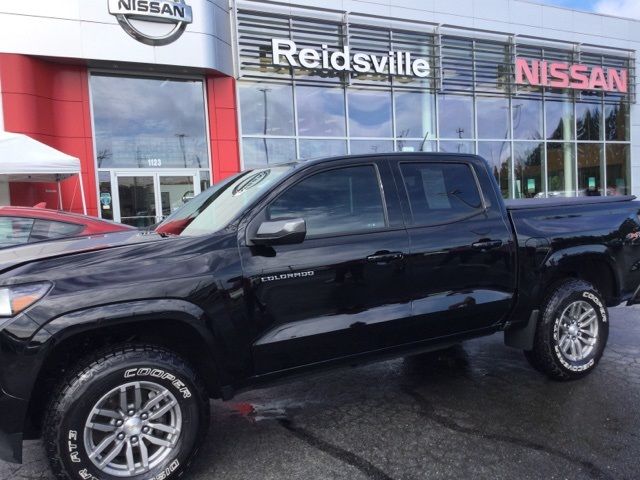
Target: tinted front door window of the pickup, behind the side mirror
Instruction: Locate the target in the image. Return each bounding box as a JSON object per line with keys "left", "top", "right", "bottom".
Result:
{"left": 267, "top": 165, "right": 386, "bottom": 236}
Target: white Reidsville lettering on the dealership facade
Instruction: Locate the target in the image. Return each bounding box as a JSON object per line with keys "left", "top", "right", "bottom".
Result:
{"left": 271, "top": 38, "right": 431, "bottom": 78}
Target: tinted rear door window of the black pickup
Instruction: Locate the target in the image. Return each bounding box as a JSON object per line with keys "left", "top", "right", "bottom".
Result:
{"left": 400, "top": 163, "right": 482, "bottom": 225}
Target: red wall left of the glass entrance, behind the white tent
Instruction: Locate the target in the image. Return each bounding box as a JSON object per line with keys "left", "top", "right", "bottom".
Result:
{"left": 0, "top": 54, "right": 98, "bottom": 216}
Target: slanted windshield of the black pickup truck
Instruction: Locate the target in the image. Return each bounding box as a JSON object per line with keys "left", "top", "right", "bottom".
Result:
{"left": 155, "top": 165, "right": 291, "bottom": 236}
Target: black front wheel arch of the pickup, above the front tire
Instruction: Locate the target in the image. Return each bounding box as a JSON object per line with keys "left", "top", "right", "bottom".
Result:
{"left": 25, "top": 300, "right": 221, "bottom": 437}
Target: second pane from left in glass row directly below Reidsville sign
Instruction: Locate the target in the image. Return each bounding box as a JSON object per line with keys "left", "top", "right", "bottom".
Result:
{"left": 296, "top": 85, "right": 346, "bottom": 137}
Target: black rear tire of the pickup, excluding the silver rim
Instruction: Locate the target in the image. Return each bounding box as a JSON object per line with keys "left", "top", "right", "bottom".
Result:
{"left": 524, "top": 279, "right": 609, "bottom": 381}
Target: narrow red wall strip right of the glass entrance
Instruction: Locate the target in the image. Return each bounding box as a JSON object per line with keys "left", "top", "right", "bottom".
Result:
{"left": 207, "top": 76, "right": 240, "bottom": 182}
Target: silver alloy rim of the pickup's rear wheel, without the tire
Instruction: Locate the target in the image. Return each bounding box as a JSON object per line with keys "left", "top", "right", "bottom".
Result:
{"left": 557, "top": 300, "right": 598, "bottom": 362}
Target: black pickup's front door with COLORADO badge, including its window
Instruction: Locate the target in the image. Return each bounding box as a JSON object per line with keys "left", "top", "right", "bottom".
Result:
{"left": 240, "top": 159, "right": 411, "bottom": 374}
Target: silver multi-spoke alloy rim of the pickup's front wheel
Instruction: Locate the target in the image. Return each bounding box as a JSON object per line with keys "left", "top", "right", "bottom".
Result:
{"left": 84, "top": 382, "right": 182, "bottom": 477}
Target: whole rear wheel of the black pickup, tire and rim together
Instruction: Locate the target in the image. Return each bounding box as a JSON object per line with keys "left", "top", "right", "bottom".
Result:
{"left": 525, "top": 280, "right": 609, "bottom": 380}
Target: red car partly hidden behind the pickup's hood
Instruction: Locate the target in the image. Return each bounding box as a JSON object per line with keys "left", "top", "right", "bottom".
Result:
{"left": 0, "top": 207, "right": 135, "bottom": 248}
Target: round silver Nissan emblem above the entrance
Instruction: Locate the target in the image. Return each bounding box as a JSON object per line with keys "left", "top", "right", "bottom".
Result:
{"left": 109, "top": 0, "right": 193, "bottom": 45}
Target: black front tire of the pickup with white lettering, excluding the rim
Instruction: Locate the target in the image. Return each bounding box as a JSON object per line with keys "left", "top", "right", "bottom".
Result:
{"left": 42, "top": 345, "right": 209, "bottom": 480}
